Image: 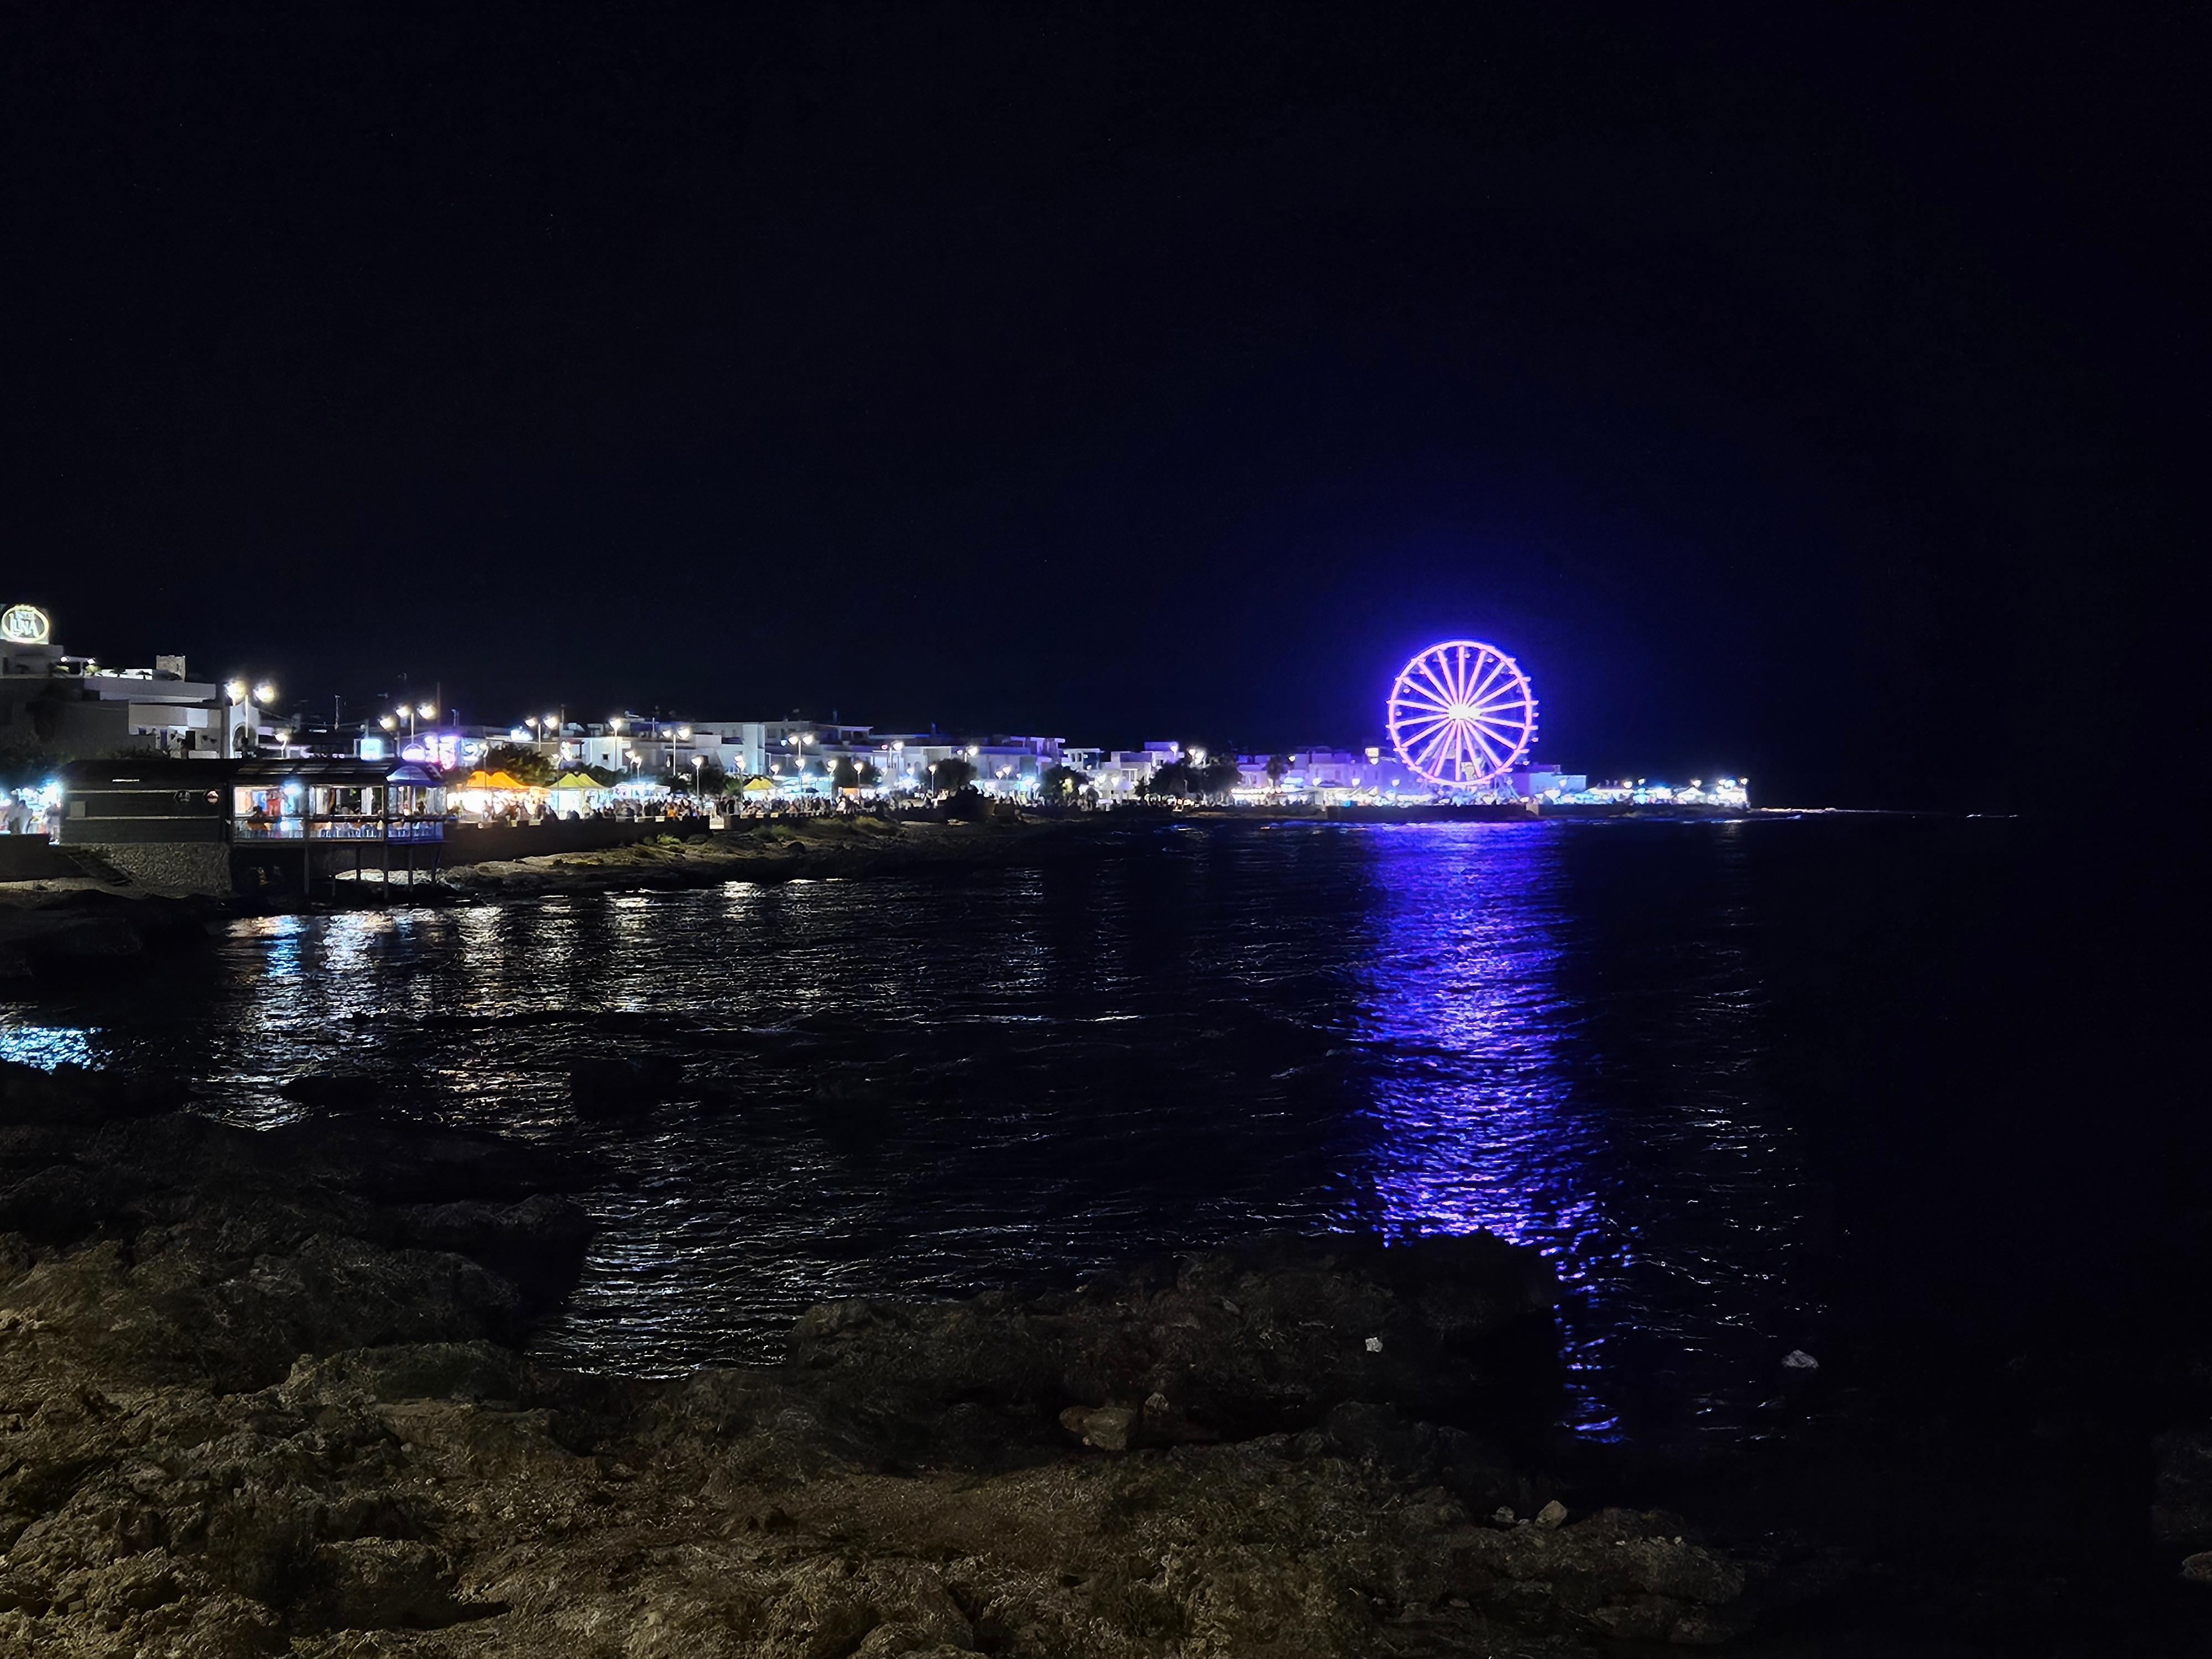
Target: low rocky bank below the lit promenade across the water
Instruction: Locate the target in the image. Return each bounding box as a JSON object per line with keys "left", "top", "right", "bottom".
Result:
{"left": 442, "top": 812, "right": 1108, "bottom": 898}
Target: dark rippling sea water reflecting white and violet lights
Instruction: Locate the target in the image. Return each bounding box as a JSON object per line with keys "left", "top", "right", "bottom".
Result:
{"left": 0, "top": 814, "right": 2154, "bottom": 1442}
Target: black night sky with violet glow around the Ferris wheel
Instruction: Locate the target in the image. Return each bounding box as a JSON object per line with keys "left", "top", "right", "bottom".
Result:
{"left": 0, "top": 4, "right": 2212, "bottom": 805}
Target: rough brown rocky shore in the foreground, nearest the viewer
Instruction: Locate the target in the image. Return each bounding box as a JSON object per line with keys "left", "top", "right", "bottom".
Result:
{"left": 0, "top": 1068, "right": 1745, "bottom": 1659}
